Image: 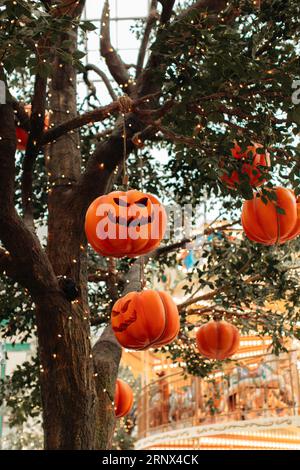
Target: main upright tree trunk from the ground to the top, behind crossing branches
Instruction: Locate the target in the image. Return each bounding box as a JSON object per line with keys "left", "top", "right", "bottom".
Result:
{"left": 36, "top": 23, "right": 101, "bottom": 449}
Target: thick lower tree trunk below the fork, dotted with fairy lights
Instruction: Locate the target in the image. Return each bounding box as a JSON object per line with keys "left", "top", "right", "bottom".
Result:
{"left": 37, "top": 292, "right": 98, "bottom": 450}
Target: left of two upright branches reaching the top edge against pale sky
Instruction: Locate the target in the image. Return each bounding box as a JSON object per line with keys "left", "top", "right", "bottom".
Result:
{"left": 100, "top": 0, "right": 133, "bottom": 95}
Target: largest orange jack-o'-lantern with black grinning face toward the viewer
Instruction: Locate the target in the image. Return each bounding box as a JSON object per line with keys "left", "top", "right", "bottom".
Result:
{"left": 85, "top": 190, "right": 167, "bottom": 258}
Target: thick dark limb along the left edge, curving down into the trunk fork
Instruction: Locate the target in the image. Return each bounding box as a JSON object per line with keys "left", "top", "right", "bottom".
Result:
{"left": 0, "top": 96, "right": 58, "bottom": 299}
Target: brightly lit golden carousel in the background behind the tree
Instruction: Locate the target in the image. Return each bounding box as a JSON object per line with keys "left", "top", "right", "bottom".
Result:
{"left": 136, "top": 337, "right": 300, "bottom": 449}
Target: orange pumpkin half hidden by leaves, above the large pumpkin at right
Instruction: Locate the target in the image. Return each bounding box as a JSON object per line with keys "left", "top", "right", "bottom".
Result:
{"left": 221, "top": 144, "right": 271, "bottom": 189}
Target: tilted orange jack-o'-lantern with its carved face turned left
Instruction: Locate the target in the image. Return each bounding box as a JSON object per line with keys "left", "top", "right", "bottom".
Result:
{"left": 111, "top": 290, "right": 180, "bottom": 350}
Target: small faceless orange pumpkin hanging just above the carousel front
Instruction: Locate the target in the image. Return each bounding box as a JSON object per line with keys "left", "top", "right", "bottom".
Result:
{"left": 196, "top": 320, "right": 240, "bottom": 360}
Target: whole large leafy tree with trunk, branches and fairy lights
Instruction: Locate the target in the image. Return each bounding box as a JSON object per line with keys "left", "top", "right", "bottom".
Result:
{"left": 0, "top": 0, "right": 300, "bottom": 449}
